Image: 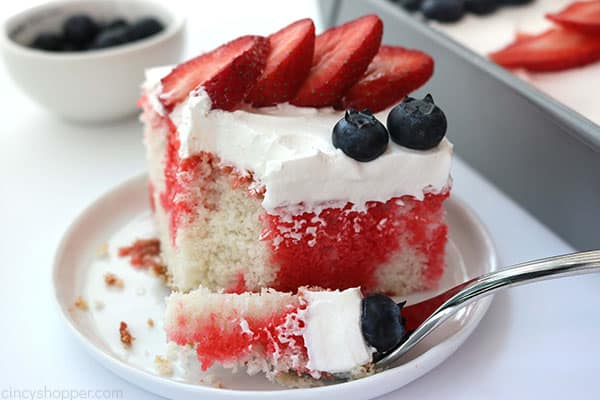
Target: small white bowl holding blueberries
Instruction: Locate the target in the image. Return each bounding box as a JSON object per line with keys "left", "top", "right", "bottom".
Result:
{"left": 0, "top": 0, "right": 185, "bottom": 122}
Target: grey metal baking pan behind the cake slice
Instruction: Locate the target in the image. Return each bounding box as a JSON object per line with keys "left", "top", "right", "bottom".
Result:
{"left": 319, "top": 0, "right": 600, "bottom": 250}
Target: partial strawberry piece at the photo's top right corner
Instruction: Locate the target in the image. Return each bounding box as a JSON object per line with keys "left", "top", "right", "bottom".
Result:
{"left": 546, "top": 0, "right": 600, "bottom": 34}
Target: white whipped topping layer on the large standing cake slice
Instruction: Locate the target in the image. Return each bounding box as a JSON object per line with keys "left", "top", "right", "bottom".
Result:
{"left": 145, "top": 68, "right": 452, "bottom": 214}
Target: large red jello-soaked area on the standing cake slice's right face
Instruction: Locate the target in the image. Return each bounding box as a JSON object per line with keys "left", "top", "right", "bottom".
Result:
{"left": 263, "top": 193, "right": 448, "bottom": 292}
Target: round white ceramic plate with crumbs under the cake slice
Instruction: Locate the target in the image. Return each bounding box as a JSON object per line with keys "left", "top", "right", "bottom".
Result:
{"left": 53, "top": 176, "right": 496, "bottom": 400}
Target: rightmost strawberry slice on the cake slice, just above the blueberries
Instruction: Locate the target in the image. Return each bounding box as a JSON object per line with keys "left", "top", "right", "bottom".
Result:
{"left": 336, "top": 46, "right": 433, "bottom": 112}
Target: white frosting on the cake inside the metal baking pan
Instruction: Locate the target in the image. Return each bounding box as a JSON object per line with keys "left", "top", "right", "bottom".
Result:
{"left": 431, "top": 0, "right": 600, "bottom": 125}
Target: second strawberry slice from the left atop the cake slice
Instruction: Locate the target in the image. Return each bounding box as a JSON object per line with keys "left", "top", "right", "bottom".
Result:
{"left": 246, "top": 19, "right": 315, "bottom": 107}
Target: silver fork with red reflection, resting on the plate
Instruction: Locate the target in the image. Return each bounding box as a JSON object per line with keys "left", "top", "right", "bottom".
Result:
{"left": 375, "top": 250, "right": 600, "bottom": 369}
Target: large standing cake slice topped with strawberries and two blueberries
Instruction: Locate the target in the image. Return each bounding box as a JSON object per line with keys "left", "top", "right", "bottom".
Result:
{"left": 140, "top": 15, "right": 452, "bottom": 301}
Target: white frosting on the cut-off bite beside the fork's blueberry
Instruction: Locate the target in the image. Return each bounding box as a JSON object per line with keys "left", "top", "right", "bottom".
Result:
{"left": 303, "top": 288, "right": 373, "bottom": 373}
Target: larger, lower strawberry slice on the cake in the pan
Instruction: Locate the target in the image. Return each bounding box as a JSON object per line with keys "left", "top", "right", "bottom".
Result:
{"left": 490, "top": 28, "right": 600, "bottom": 71}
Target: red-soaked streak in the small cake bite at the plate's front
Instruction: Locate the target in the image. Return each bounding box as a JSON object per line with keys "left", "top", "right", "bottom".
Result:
{"left": 167, "top": 306, "right": 307, "bottom": 373}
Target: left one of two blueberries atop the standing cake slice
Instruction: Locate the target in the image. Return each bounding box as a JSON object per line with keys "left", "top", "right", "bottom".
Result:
{"left": 332, "top": 110, "right": 389, "bottom": 162}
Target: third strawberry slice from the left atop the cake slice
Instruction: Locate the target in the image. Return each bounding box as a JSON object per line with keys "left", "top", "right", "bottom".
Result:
{"left": 291, "top": 15, "right": 383, "bottom": 107}
